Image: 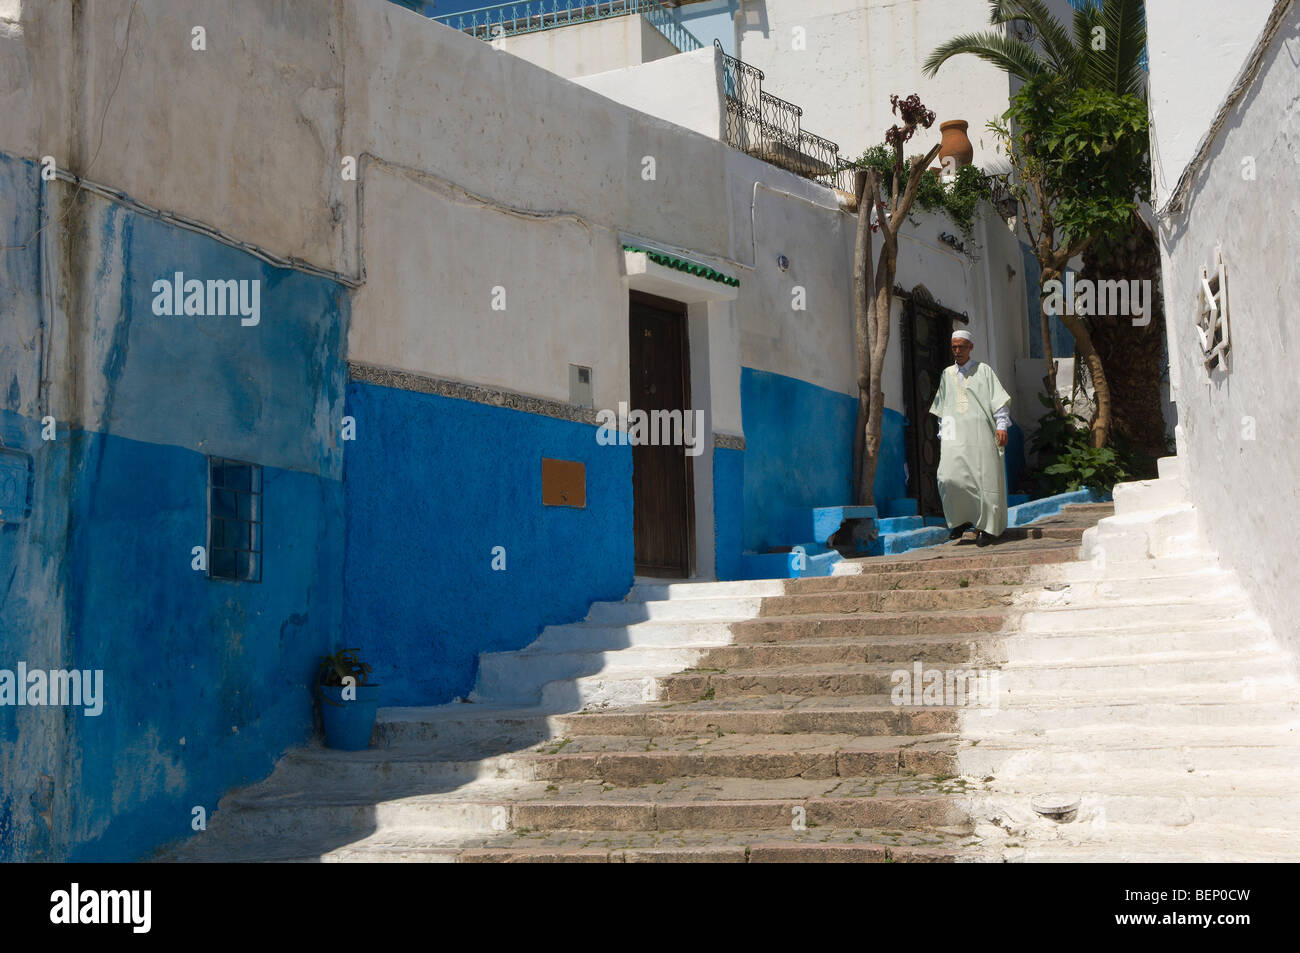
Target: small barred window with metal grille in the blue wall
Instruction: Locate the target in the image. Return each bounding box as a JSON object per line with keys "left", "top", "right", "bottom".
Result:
{"left": 208, "top": 456, "right": 263, "bottom": 582}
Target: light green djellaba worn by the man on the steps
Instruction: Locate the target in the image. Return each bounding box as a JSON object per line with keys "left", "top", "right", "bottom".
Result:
{"left": 930, "top": 361, "right": 1011, "bottom": 536}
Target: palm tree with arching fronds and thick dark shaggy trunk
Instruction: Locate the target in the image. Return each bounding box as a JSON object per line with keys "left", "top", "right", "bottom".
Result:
{"left": 924, "top": 0, "right": 1165, "bottom": 456}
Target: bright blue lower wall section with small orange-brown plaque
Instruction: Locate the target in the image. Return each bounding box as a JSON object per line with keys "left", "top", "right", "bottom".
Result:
{"left": 345, "top": 381, "right": 633, "bottom": 705}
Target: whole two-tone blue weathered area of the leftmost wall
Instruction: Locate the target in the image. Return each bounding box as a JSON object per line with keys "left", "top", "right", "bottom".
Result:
{"left": 0, "top": 150, "right": 347, "bottom": 861}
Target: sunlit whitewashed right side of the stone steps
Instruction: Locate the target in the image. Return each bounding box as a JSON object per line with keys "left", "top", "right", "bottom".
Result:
{"left": 958, "top": 458, "right": 1300, "bottom": 862}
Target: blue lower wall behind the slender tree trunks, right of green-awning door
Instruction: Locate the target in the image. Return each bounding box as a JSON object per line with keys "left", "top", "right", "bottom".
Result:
{"left": 740, "top": 368, "right": 906, "bottom": 553}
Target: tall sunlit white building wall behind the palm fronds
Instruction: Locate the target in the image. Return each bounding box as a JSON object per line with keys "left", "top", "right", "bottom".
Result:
{"left": 737, "top": 0, "right": 1009, "bottom": 165}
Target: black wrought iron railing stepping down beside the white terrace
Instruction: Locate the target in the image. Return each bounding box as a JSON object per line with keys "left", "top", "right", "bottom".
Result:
{"left": 714, "top": 40, "right": 852, "bottom": 186}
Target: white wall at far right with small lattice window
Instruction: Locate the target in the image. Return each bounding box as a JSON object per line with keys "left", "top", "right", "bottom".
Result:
{"left": 1151, "top": 3, "right": 1300, "bottom": 654}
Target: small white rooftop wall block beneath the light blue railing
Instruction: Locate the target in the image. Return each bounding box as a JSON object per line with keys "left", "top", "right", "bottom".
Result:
{"left": 495, "top": 16, "right": 677, "bottom": 77}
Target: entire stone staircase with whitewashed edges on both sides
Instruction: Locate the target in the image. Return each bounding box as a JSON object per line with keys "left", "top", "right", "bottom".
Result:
{"left": 163, "top": 464, "right": 1300, "bottom": 862}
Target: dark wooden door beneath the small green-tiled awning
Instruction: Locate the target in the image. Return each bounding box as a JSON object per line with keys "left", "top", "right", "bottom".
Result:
{"left": 628, "top": 293, "right": 703, "bottom": 577}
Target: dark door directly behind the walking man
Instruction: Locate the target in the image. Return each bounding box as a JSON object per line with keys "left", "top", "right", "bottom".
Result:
{"left": 902, "top": 295, "right": 958, "bottom": 516}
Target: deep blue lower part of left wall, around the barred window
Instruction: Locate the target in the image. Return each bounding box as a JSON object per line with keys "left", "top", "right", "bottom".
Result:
{"left": 59, "top": 433, "right": 343, "bottom": 861}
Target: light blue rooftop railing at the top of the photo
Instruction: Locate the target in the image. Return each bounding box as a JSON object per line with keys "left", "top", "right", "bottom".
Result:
{"left": 433, "top": 0, "right": 705, "bottom": 53}
